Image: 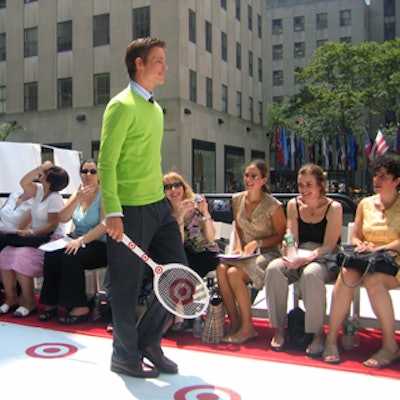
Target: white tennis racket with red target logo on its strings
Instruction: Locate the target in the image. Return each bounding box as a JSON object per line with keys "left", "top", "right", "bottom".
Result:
{"left": 122, "top": 234, "right": 210, "bottom": 319}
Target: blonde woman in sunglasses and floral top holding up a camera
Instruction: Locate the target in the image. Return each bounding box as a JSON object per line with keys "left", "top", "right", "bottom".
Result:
{"left": 163, "top": 172, "right": 220, "bottom": 331}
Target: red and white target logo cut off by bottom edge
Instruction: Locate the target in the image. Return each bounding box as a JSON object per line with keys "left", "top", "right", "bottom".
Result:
{"left": 174, "top": 385, "right": 241, "bottom": 400}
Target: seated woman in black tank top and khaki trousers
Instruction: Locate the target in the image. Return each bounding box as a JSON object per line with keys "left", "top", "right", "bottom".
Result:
{"left": 265, "top": 164, "right": 343, "bottom": 357}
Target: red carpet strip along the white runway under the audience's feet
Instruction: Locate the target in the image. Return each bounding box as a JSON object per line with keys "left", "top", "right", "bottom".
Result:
{"left": 0, "top": 314, "right": 400, "bottom": 379}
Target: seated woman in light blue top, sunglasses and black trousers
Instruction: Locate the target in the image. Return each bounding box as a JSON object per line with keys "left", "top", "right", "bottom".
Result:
{"left": 39, "top": 159, "right": 107, "bottom": 325}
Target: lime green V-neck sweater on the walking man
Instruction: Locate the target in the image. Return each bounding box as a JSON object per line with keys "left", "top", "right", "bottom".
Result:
{"left": 98, "top": 87, "right": 164, "bottom": 214}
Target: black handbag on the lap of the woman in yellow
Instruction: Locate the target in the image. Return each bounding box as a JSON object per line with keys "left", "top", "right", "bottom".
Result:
{"left": 337, "top": 245, "right": 400, "bottom": 287}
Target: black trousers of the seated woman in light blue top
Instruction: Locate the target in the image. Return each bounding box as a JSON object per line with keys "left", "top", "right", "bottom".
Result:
{"left": 40, "top": 241, "right": 107, "bottom": 309}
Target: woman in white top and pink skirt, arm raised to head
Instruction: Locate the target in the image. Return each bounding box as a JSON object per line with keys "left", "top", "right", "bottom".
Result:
{"left": 0, "top": 161, "right": 69, "bottom": 318}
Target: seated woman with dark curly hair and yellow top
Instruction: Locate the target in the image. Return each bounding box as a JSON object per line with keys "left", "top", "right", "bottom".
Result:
{"left": 323, "top": 153, "right": 400, "bottom": 368}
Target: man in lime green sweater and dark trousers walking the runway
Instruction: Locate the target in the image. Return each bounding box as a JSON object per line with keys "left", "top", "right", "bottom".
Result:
{"left": 98, "top": 38, "right": 187, "bottom": 378}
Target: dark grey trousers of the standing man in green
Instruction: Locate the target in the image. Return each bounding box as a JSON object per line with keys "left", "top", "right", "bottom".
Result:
{"left": 107, "top": 199, "right": 187, "bottom": 364}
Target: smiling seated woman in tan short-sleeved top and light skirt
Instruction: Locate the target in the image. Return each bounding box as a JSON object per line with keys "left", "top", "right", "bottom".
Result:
{"left": 217, "top": 160, "right": 286, "bottom": 344}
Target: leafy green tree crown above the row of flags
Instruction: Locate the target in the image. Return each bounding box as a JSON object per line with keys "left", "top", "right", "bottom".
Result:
{"left": 268, "top": 39, "right": 400, "bottom": 137}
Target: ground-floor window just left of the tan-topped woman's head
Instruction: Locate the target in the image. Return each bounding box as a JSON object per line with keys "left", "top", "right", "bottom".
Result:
{"left": 225, "top": 146, "right": 245, "bottom": 193}
